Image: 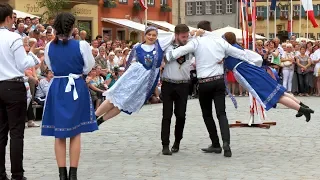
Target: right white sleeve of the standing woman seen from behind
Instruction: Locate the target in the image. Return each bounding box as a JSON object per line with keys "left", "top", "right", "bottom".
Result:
{"left": 79, "top": 41, "right": 95, "bottom": 74}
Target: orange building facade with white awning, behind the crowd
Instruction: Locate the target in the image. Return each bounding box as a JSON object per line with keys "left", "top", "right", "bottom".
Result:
{"left": 98, "top": 0, "right": 172, "bottom": 41}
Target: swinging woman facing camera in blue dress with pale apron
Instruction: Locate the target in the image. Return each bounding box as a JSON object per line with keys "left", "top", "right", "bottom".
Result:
{"left": 96, "top": 26, "right": 174, "bottom": 125}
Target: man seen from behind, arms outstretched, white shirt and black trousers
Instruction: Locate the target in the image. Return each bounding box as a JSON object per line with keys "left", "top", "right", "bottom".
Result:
{"left": 166, "top": 21, "right": 248, "bottom": 157}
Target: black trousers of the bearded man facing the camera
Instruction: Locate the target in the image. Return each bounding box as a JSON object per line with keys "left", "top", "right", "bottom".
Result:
{"left": 161, "top": 82, "right": 189, "bottom": 145}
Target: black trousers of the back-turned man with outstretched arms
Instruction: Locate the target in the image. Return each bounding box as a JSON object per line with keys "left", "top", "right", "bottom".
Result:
{"left": 199, "top": 79, "right": 230, "bottom": 147}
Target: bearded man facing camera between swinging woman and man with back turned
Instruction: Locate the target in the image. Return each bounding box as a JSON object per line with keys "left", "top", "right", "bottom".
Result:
{"left": 161, "top": 24, "right": 192, "bottom": 155}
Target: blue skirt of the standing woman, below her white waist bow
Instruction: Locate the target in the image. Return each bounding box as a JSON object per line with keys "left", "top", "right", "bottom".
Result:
{"left": 41, "top": 78, "right": 98, "bottom": 138}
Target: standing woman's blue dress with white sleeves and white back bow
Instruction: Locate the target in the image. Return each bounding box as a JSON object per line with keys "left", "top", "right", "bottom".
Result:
{"left": 41, "top": 40, "right": 98, "bottom": 138}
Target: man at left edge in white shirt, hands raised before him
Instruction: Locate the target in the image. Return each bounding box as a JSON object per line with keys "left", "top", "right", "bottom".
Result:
{"left": 0, "top": 4, "right": 40, "bottom": 180}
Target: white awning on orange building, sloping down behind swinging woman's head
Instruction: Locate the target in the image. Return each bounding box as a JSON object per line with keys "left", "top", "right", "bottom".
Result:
{"left": 102, "top": 18, "right": 166, "bottom": 34}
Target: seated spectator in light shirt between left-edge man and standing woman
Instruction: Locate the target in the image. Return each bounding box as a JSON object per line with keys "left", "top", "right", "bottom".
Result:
{"left": 35, "top": 70, "right": 53, "bottom": 106}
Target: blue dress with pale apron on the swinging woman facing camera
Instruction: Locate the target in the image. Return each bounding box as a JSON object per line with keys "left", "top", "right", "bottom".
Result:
{"left": 104, "top": 40, "right": 163, "bottom": 114}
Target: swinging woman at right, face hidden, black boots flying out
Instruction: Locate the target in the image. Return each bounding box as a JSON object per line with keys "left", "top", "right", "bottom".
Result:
{"left": 224, "top": 32, "right": 314, "bottom": 122}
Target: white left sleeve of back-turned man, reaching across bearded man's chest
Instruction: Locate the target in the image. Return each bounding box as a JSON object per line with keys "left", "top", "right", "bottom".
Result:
{"left": 166, "top": 38, "right": 199, "bottom": 62}
